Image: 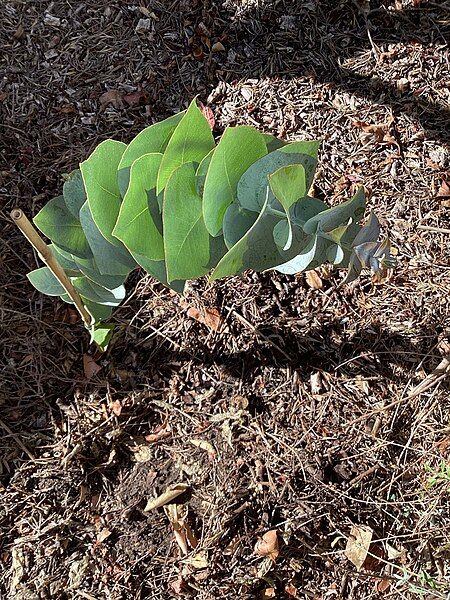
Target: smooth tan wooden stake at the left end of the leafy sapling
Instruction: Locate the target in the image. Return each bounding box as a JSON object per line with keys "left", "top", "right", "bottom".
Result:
{"left": 10, "top": 208, "right": 92, "bottom": 328}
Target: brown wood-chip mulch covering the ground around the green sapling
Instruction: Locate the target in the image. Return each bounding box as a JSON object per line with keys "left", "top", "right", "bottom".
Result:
{"left": 0, "top": 0, "right": 450, "bottom": 600}
